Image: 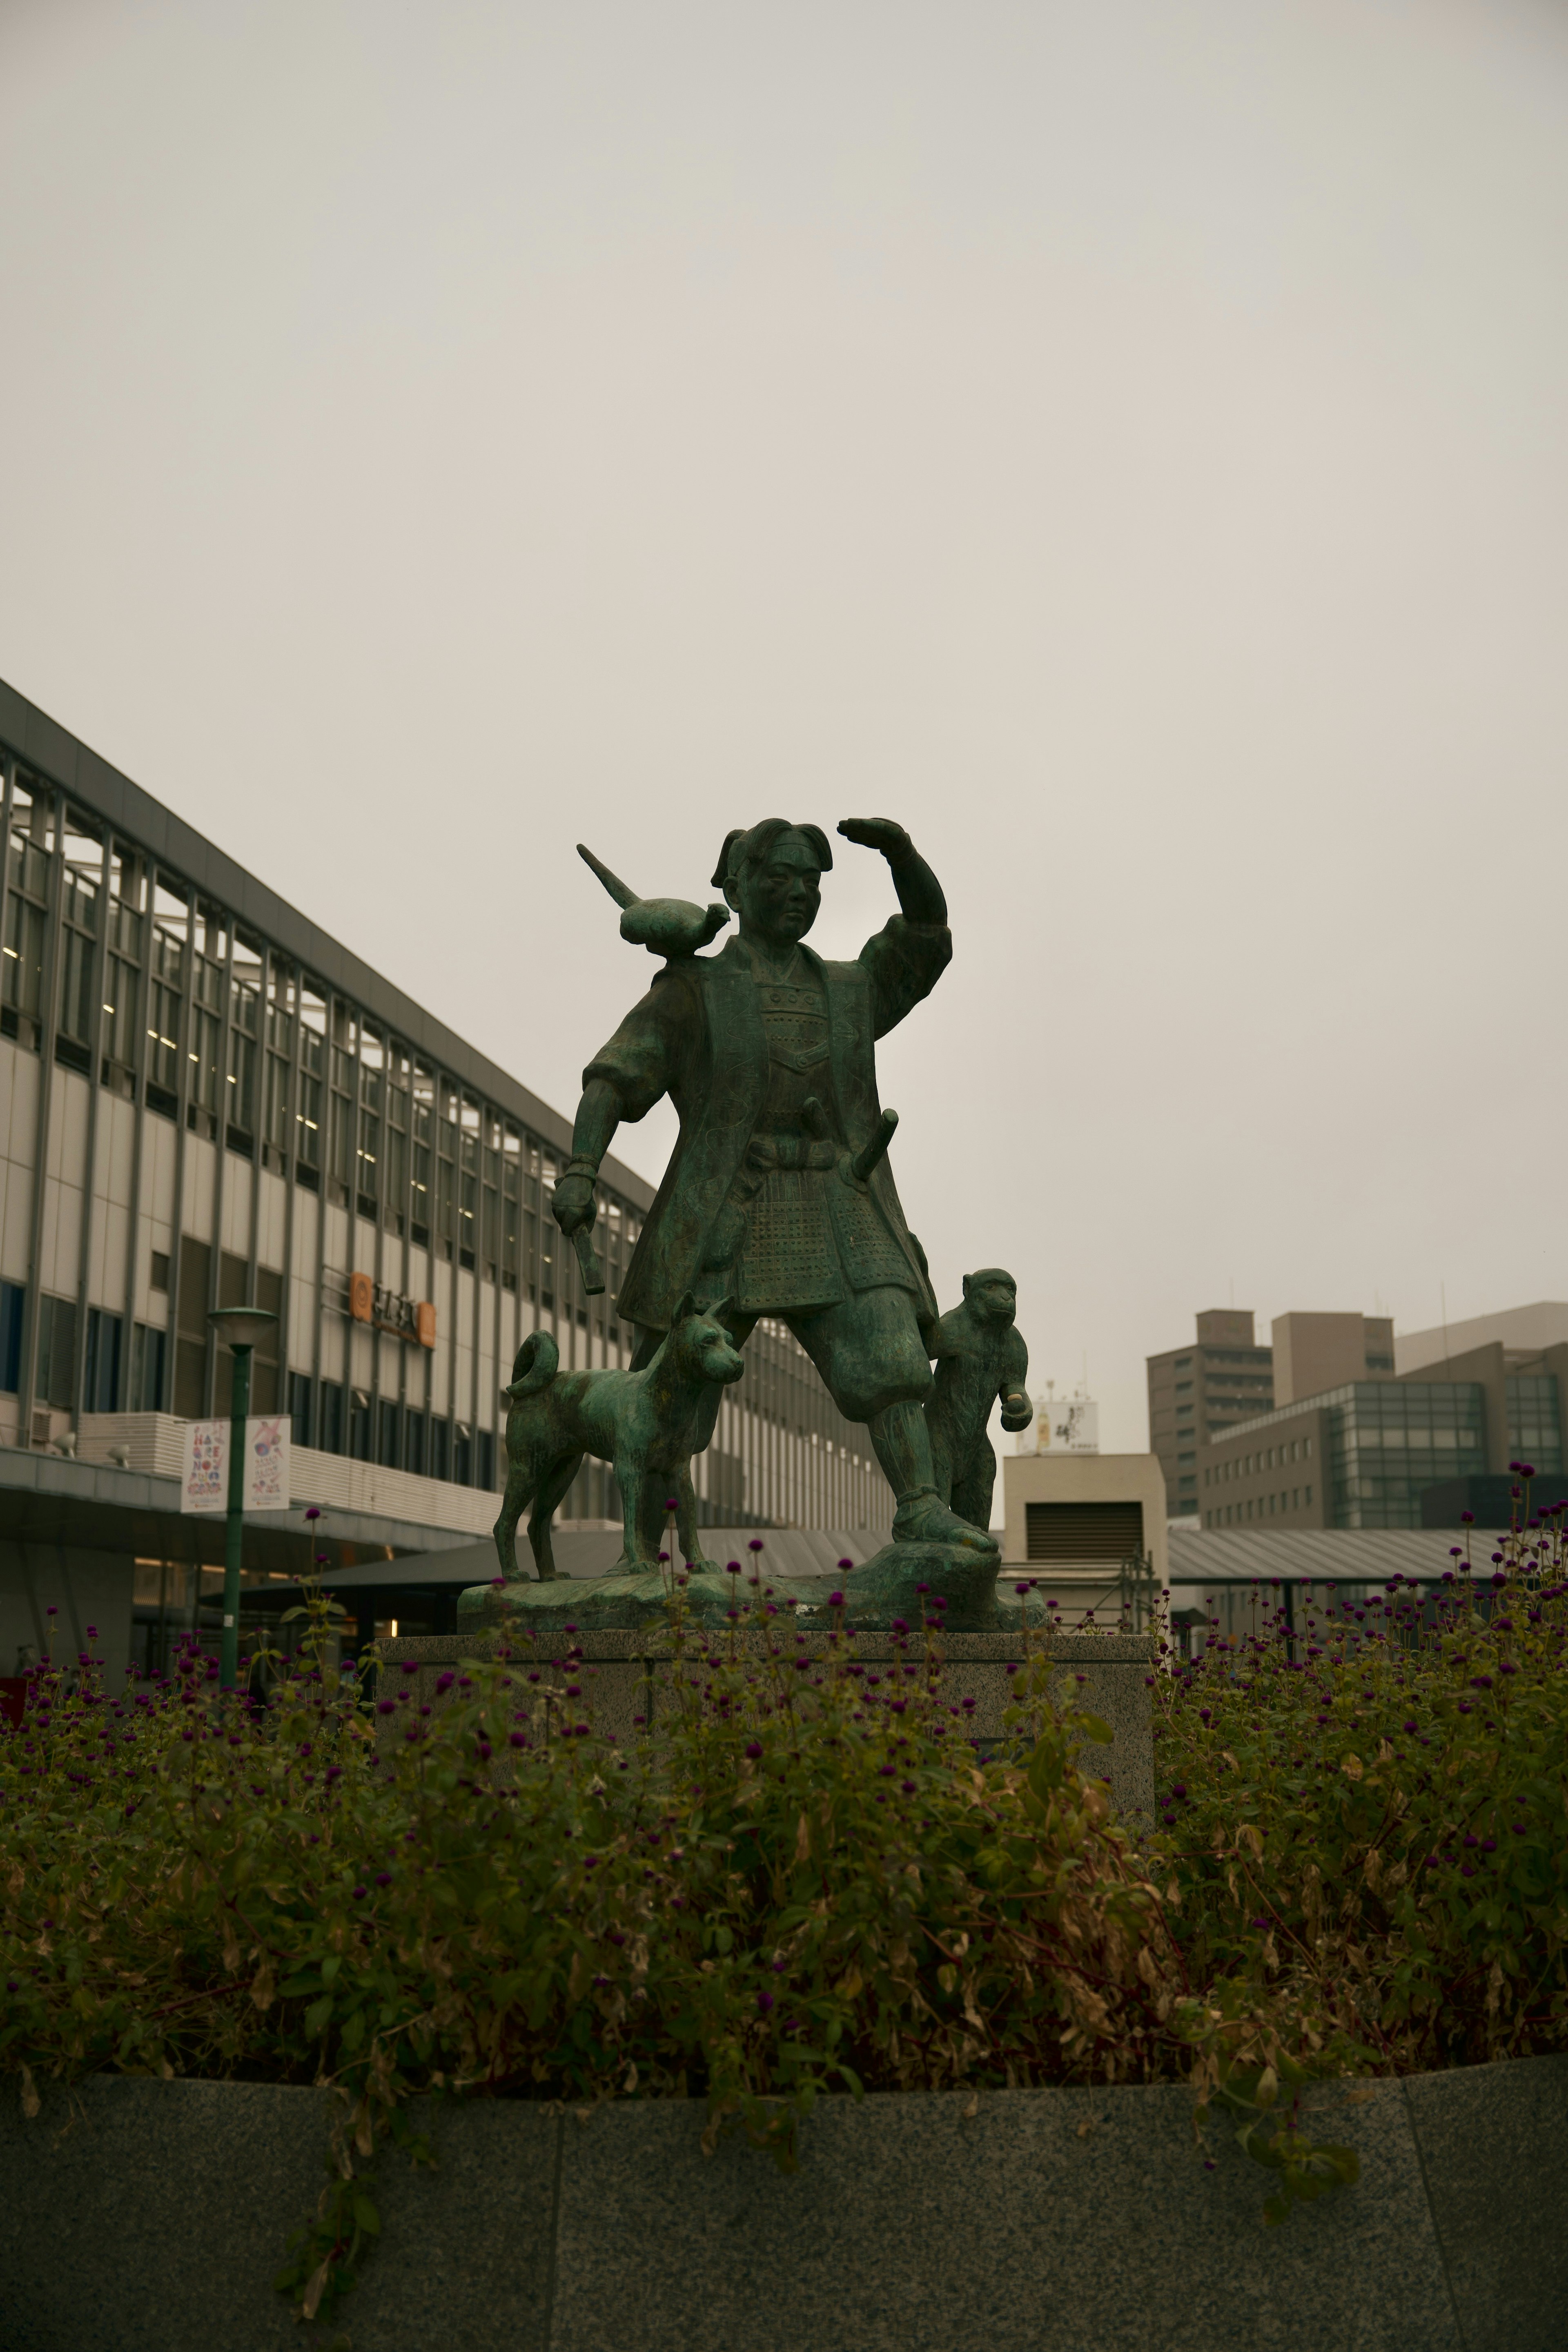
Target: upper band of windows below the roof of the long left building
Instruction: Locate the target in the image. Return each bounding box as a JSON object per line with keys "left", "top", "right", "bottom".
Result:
{"left": 0, "top": 769, "right": 637, "bottom": 1308}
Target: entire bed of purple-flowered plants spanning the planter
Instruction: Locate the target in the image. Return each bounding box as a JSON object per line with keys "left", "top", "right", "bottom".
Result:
{"left": 0, "top": 1524, "right": 1568, "bottom": 2343}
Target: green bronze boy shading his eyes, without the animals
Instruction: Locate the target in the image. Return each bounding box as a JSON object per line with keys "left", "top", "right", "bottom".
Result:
{"left": 555, "top": 816, "right": 994, "bottom": 1552}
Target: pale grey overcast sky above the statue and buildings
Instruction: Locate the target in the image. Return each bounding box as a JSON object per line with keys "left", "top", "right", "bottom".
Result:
{"left": 0, "top": 0, "right": 1568, "bottom": 1449}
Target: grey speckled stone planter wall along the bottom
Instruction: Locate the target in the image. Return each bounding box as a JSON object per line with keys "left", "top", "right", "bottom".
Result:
{"left": 0, "top": 2058, "right": 1568, "bottom": 2352}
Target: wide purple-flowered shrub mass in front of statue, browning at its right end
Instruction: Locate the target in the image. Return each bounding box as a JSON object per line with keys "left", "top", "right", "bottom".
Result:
{"left": 0, "top": 1578, "right": 1347, "bottom": 2314}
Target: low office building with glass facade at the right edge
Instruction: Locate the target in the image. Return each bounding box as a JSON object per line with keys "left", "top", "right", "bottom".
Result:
{"left": 1199, "top": 1308, "right": 1568, "bottom": 1529}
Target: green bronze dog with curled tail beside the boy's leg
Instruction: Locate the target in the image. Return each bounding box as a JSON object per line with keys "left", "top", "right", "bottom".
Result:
{"left": 496, "top": 1291, "right": 745, "bottom": 1583}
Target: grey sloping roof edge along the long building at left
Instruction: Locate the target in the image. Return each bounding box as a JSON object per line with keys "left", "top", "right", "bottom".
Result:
{"left": 0, "top": 680, "right": 653, "bottom": 1216}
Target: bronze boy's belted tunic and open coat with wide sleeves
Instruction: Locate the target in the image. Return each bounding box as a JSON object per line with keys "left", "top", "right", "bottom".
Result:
{"left": 583, "top": 915, "right": 952, "bottom": 1331}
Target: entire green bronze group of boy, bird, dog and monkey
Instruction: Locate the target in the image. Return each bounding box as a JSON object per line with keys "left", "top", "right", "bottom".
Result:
{"left": 479, "top": 816, "right": 1030, "bottom": 1623}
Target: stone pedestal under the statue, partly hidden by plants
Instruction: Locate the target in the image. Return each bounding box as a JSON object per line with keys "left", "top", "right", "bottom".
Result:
{"left": 381, "top": 1625, "right": 1154, "bottom": 1816}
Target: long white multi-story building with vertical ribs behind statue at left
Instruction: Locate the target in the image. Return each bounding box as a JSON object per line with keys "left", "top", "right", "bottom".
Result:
{"left": 0, "top": 684, "right": 891, "bottom": 1665}
